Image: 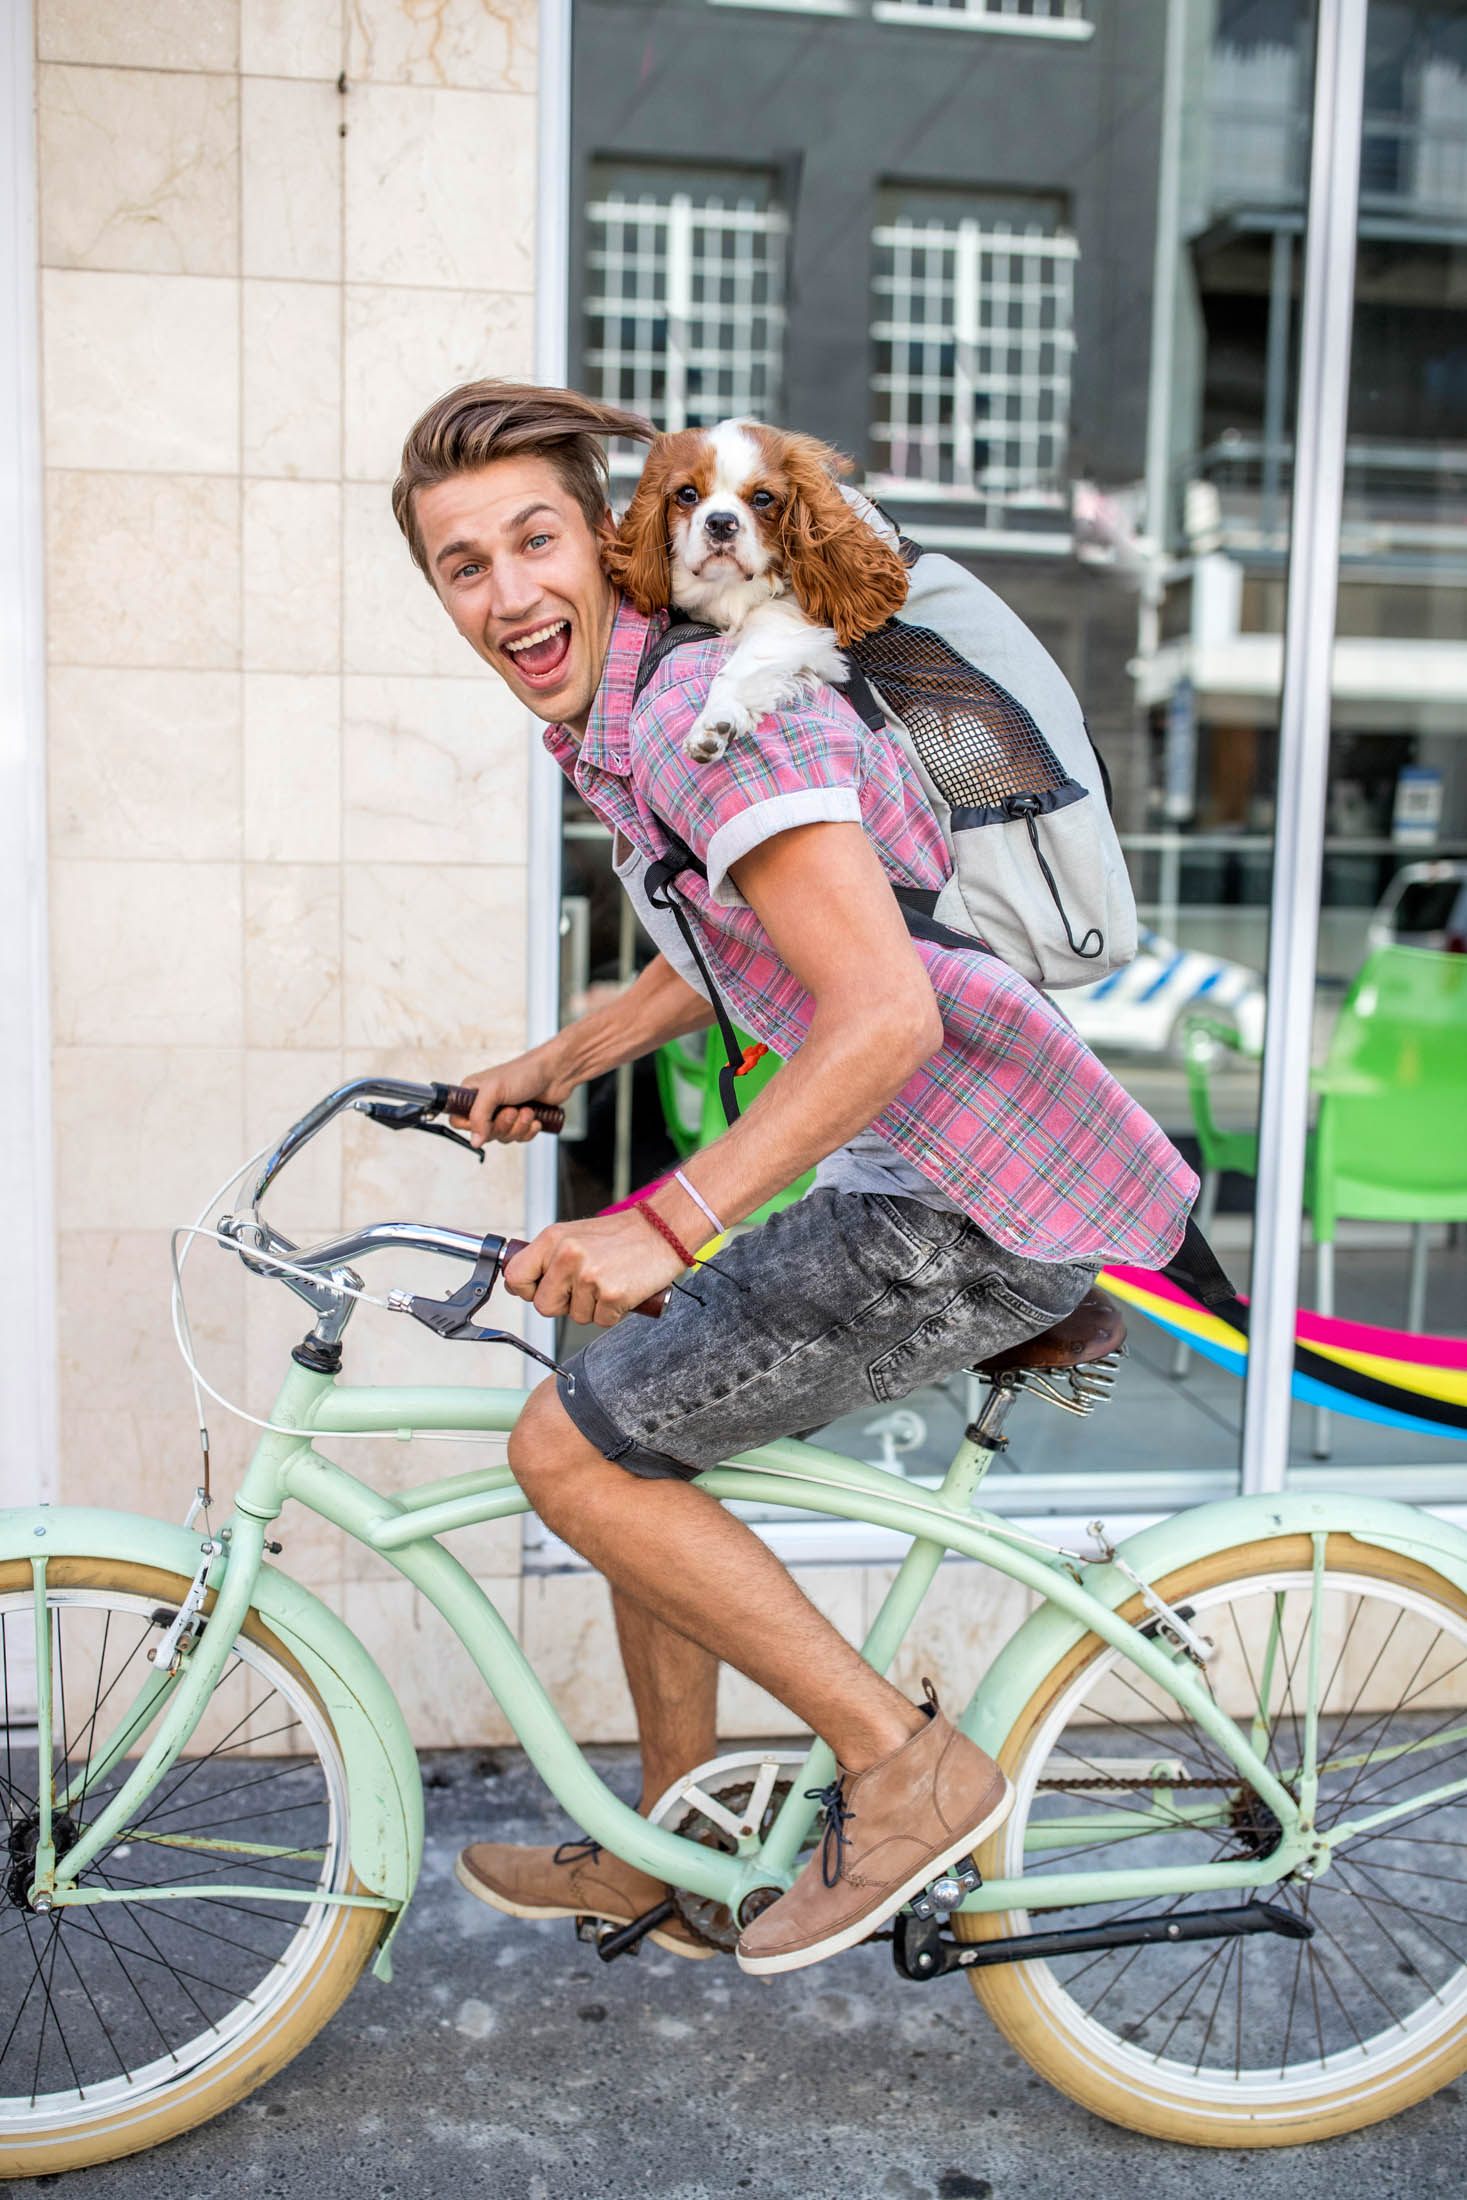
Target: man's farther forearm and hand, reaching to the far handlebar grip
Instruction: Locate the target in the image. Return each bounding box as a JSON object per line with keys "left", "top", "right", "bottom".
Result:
{"left": 451, "top": 955, "right": 713, "bottom": 1146}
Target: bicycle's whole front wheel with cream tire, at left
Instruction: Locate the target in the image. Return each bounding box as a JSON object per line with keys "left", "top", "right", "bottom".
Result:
{"left": 0, "top": 1558, "right": 383, "bottom": 2178}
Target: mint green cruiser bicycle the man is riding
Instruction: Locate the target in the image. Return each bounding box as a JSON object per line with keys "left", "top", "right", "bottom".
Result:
{"left": 0, "top": 1080, "right": 1467, "bottom": 2178}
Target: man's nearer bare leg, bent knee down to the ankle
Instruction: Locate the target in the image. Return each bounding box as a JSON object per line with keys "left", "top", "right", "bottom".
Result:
{"left": 510, "top": 1384, "right": 922, "bottom": 1784}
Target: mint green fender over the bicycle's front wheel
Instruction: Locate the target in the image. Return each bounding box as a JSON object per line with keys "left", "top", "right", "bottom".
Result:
{"left": 0, "top": 1505, "right": 422, "bottom": 1976}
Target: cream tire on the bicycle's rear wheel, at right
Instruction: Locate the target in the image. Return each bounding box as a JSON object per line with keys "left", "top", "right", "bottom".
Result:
{"left": 952, "top": 1536, "right": 1467, "bottom": 2147}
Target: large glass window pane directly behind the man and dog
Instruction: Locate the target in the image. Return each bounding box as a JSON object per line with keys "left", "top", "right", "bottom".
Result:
{"left": 563, "top": 0, "right": 1328, "bottom": 1518}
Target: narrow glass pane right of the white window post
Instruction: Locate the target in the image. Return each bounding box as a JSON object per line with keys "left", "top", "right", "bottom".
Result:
{"left": 1291, "top": 0, "right": 1467, "bottom": 1498}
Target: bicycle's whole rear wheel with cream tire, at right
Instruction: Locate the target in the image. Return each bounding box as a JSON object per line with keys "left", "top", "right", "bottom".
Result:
{"left": 955, "top": 1536, "right": 1467, "bottom": 2147}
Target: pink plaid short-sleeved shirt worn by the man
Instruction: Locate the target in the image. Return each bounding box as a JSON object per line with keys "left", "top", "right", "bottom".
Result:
{"left": 545, "top": 603, "right": 1196, "bottom": 1267}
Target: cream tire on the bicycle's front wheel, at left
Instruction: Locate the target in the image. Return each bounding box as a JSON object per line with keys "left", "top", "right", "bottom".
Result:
{"left": 0, "top": 1558, "right": 385, "bottom": 2178}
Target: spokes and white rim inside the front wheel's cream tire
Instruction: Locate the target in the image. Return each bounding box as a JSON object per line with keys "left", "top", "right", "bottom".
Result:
{"left": 0, "top": 1564, "right": 351, "bottom": 2145}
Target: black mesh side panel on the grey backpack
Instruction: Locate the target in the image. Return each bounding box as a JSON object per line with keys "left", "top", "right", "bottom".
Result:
{"left": 847, "top": 620, "right": 1069, "bottom": 810}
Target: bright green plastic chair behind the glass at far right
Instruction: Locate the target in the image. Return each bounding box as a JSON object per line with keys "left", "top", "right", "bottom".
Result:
{"left": 1311, "top": 946, "right": 1467, "bottom": 1459}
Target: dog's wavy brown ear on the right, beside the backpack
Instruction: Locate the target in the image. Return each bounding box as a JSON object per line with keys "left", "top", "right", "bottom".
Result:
{"left": 781, "top": 436, "right": 906, "bottom": 645}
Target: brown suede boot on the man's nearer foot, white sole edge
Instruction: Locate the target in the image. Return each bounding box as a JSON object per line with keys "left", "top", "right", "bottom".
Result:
{"left": 739, "top": 1681, "right": 1014, "bottom": 1978}
